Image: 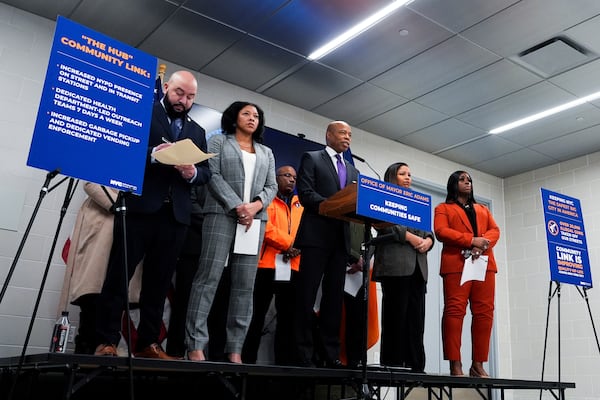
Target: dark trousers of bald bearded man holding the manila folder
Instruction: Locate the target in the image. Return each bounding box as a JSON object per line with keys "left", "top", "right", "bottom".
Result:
{"left": 96, "top": 204, "right": 187, "bottom": 351}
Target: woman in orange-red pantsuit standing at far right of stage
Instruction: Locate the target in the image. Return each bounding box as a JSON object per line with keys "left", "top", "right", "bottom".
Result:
{"left": 434, "top": 171, "right": 500, "bottom": 377}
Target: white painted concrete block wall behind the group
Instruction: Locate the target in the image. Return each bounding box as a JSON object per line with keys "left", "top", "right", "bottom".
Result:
{"left": 8, "top": 3, "right": 600, "bottom": 400}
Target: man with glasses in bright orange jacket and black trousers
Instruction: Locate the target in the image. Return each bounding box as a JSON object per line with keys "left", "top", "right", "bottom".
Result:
{"left": 242, "top": 166, "right": 304, "bottom": 365}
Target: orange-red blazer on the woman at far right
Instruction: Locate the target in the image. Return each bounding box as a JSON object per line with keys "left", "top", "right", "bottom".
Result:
{"left": 433, "top": 203, "right": 500, "bottom": 275}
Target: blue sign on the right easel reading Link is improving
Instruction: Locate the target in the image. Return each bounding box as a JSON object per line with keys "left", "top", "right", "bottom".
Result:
{"left": 541, "top": 188, "right": 592, "bottom": 288}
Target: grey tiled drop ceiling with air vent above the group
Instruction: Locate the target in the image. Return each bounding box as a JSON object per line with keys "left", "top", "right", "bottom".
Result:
{"left": 7, "top": 0, "right": 600, "bottom": 177}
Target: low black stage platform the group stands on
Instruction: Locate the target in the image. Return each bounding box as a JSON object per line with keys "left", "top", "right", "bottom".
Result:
{"left": 0, "top": 353, "right": 575, "bottom": 400}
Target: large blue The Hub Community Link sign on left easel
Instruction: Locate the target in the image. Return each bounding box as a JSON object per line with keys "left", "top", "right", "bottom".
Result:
{"left": 27, "top": 17, "right": 157, "bottom": 194}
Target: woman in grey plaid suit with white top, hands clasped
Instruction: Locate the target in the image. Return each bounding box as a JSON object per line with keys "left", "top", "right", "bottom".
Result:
{"left": 186, "top": 101, "right": 277, "bottom": 363}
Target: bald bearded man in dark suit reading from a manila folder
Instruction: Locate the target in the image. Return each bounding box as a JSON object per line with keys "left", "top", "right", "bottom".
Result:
{"left": 95, "top": 71, "right": 210, "bottom": 359}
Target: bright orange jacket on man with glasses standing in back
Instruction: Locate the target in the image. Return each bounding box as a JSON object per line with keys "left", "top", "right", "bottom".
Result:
{"left": 258, "top": 195, "right": 304, "bottom": 271}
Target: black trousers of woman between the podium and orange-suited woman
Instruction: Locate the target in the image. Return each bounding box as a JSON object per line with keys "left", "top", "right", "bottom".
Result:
{"left": 380, "top": 268, "right": 426, "bottom": 372}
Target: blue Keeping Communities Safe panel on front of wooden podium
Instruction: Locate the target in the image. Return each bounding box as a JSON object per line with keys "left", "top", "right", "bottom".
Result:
{"left": 356, "top": 175, "right": 431, "bottom": 231}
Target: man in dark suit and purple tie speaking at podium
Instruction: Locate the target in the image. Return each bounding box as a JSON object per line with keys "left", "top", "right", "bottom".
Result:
{"left": 295, "top": 121, "right": 358, "bottom": 368}
